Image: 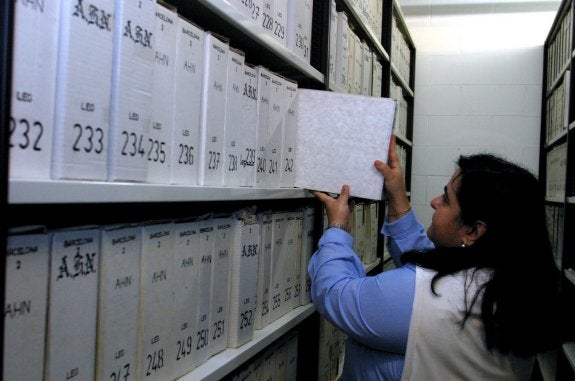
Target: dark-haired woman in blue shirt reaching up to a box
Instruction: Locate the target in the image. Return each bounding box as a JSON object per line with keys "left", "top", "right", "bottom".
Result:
{"left": 308, "top": 139, "right": 559, "bottom": 381}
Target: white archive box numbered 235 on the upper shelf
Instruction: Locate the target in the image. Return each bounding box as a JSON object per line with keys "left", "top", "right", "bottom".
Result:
{"left": 148, "top": 2, "right": 178, "bottom": 184}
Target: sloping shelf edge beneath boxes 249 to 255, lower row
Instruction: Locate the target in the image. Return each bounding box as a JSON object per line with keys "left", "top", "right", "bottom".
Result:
{"left": 177, "top": 303, "right": 315, "bottom": 381}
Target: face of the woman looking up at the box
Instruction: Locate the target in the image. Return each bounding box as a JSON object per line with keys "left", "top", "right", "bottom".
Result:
{"left": 427, "top": 171, "right": 469, "bottom": 247}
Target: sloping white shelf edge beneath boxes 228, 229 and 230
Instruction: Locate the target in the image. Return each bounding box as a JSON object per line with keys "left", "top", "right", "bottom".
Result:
{"left": 187, "top": 0, "right": 325, "bottom": 83}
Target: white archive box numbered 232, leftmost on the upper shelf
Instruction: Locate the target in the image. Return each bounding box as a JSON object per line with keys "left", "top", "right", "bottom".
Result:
{"left": 9, "top": 1, "right": 61, "bottom": 180}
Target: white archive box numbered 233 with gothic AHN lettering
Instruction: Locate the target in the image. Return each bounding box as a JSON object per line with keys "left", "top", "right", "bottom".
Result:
{"left": 52, "top": 0, "right": 114, "bottom": 180}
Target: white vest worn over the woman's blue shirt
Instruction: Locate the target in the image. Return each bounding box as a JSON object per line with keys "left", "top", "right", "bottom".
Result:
{"left": 402, "top": 266, "right": 534, "bottom": 381}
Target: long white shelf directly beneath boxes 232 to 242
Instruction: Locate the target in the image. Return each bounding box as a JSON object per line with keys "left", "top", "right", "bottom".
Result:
{"left": 8, "top": 180, "right": 313, "bottom": 204}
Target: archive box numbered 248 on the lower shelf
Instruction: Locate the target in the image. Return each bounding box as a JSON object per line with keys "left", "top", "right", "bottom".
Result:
{"left": 137, "top": 221, "right": 176, "bottom": 380}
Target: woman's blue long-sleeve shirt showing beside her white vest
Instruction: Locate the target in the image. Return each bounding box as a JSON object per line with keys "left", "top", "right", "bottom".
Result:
{"left": 308, "top": 212, "right": 433, "bottom": 380}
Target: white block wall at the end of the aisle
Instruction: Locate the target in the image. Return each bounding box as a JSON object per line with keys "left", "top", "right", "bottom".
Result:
{"left": 399, "top": 0, "right": 559, "bottom": 226}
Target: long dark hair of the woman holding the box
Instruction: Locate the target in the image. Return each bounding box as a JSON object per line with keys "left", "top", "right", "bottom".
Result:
{"left": 402, "top": 154, "right": 559, "bottom": 356}
